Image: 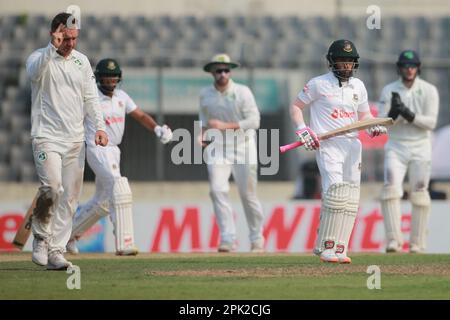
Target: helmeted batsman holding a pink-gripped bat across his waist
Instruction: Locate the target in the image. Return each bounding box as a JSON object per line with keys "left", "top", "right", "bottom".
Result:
{"left": 291, "top": 40, "right": 387, "bottom": 263}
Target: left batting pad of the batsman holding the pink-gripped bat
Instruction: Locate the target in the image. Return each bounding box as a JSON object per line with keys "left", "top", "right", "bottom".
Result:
{"left": 314, "top": 182, "right": 350, "bottom": 252}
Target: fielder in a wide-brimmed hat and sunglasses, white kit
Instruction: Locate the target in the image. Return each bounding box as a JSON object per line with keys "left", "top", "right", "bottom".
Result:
{"left": 199, "top": 54, "right": 264, "bottom": 253}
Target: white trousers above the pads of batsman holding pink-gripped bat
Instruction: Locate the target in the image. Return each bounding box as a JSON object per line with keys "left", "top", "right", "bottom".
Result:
{"left": 316, "top": 137, "right": 362, "bottom": 194}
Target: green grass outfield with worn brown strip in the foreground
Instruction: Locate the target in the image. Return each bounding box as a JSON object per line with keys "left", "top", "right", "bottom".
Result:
{"left": 0, "top": 253, "right": 450, "bottom": 300}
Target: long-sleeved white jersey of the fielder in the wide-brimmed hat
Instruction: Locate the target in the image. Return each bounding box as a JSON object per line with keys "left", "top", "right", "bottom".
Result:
{"left": 199, "top": 79, "right": 260, "bottom": 142}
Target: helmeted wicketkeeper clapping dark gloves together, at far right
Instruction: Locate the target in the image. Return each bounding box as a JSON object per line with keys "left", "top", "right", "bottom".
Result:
{"left": 380, "top": 50, "right": 439, "bottom": 253}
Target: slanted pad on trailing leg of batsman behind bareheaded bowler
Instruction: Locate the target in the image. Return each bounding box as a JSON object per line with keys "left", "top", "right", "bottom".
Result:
{"left": 70, "top": 202, "right": 109, "bottom": 239}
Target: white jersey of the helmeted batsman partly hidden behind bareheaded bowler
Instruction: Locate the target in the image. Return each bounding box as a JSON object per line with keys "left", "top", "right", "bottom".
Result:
{"left": 85, "top": 89, "right": 137, "bottom": 146}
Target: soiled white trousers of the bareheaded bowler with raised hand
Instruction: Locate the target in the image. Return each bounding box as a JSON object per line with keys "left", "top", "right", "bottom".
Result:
{"left": 32, "top": 138, "right": 85, "bottom": 252}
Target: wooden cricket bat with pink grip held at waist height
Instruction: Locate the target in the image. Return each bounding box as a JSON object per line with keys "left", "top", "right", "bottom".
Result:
{"left": 280, "top": 118, "right": 394, "bottom": 153}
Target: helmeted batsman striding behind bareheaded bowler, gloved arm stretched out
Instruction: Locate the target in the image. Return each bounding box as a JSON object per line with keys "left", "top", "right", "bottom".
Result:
{"left": 67, "top": 58, "right": 172, "bottom": 255}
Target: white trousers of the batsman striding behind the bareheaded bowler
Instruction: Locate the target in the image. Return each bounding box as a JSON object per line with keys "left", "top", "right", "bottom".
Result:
{"left": 81, "top": 145, "right": 121, "bottom": 224}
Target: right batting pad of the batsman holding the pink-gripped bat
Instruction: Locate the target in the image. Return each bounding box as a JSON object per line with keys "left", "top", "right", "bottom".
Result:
{"left": 337, "top": 184, "right": 360, "bottom": 253}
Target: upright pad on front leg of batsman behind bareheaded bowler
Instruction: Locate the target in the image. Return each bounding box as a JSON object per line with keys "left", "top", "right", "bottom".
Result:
{"left": 113, "top": 177, "right": 134, "bottom": 252}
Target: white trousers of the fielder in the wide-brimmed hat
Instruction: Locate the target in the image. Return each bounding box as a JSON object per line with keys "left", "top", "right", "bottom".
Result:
{"left": 207, "top": 164, "right": 264, "bottom": 243}
